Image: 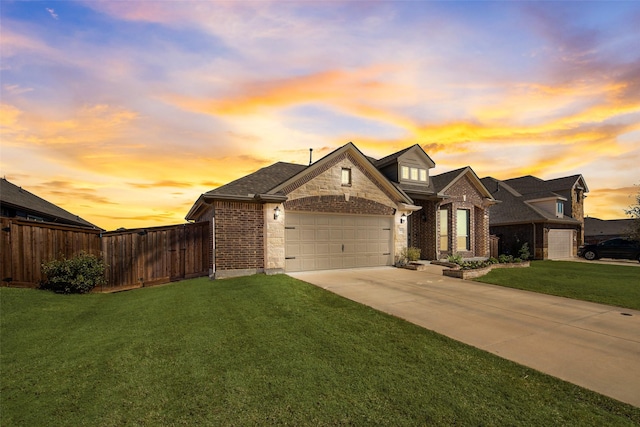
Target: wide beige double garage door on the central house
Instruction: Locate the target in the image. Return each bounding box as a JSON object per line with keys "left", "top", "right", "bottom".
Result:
{"left": 285, "top": 213, "right": 393, "bottom": 271}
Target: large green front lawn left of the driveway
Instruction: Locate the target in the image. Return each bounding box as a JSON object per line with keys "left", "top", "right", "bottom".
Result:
{"left": 0, "top": 275, "right": 640, "bottom": 426}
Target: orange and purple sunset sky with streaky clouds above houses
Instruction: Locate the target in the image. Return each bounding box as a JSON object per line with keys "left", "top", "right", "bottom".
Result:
{"left": 0, "top": 0, "right": 640, "bottom": 230}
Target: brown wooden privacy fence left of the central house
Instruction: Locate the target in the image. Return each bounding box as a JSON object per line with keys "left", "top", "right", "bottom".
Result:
{"left": 0, "top": 218, "right": 211, "bottom": 292}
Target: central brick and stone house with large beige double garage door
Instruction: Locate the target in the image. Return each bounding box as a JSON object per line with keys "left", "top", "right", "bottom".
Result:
{"left": 186, "top": 143, "right": 495, "bottom": 278}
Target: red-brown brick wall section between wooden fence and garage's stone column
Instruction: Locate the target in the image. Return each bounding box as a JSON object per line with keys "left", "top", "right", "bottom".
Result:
{"left": 214, "top": 201, "right": 265, "bottom": 272}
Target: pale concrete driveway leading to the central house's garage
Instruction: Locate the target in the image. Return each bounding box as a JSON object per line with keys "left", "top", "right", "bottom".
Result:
{"left": 290, "top": 266, "right": 640, "bottom": 407}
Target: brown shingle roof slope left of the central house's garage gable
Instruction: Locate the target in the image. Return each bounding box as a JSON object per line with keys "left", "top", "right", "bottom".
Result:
{"left": 205, "top": 162, "right": 307, "bottom": 197}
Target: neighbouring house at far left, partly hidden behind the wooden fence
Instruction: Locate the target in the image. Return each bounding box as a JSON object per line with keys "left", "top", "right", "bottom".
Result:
{"left": 0, "top": 178, "right": 100, "bottom": 229}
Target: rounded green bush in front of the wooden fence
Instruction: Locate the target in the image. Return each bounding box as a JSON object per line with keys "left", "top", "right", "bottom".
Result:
{"left": 41, "top": 251, "right": 106, "bottom": 294}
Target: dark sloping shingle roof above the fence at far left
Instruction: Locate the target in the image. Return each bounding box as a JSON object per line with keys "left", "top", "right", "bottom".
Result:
{"left": 0, "top": 178, "right": 100, "bottom": 229}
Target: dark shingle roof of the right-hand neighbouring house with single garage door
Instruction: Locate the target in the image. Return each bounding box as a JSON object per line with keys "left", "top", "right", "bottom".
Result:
{"left": 480, "top": 175, "right": 580, "bottom": 225}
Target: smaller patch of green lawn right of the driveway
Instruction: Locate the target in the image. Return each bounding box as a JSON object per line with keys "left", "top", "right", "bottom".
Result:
{"left": 474, "top": 261, "right": 640, "bottom": 310}
